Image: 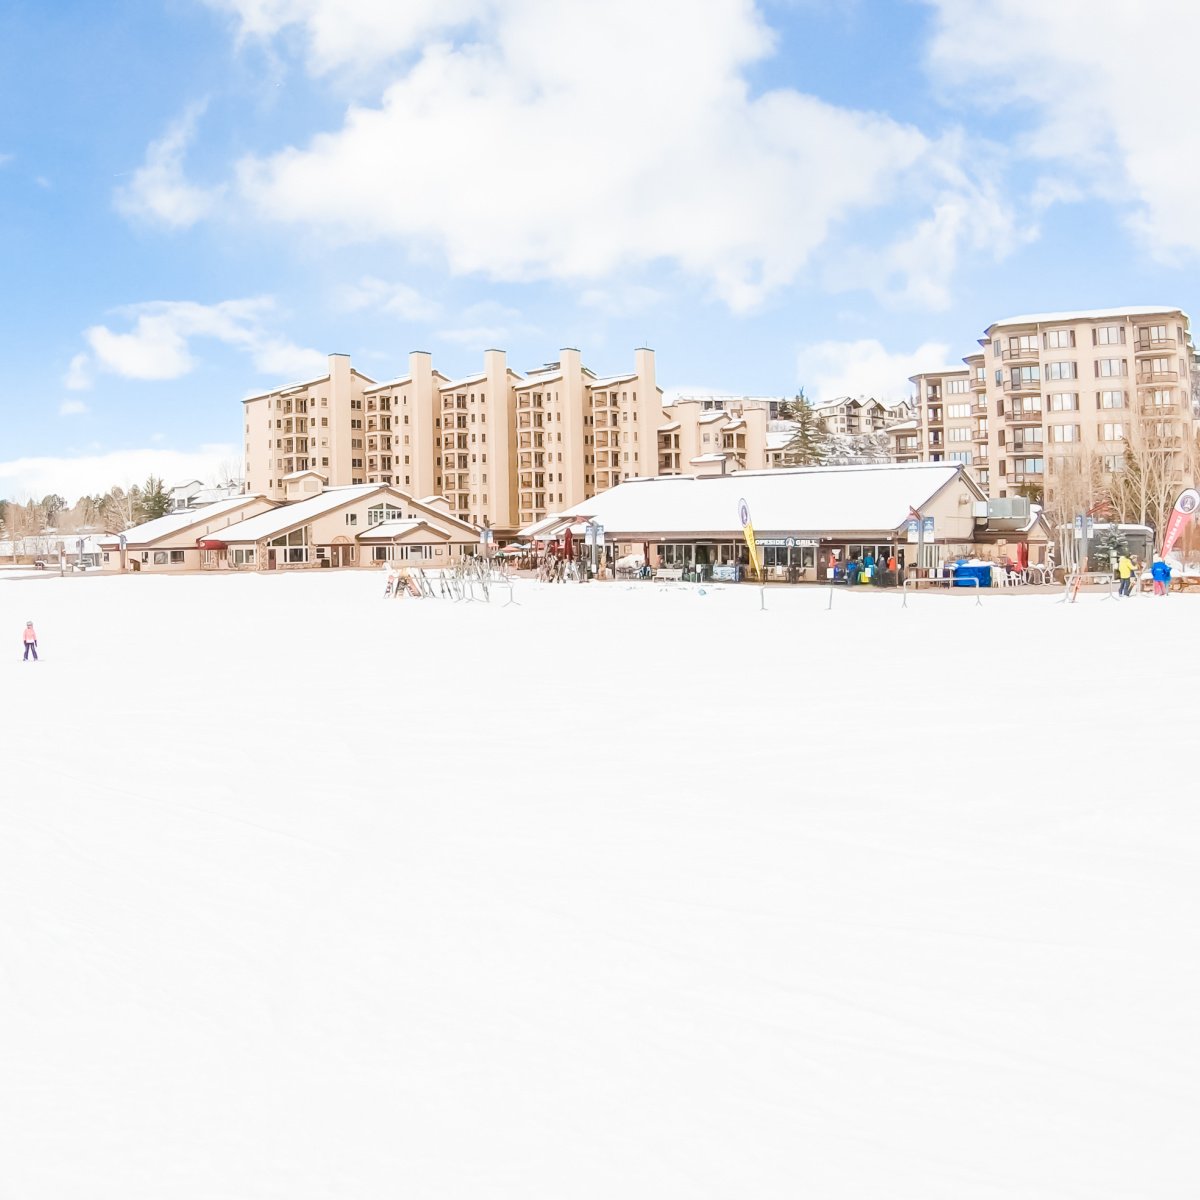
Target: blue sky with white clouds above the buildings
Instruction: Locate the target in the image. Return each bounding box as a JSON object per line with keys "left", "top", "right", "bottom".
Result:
{"left": 0, "top": 0, "right": 1200, "bottom": 500}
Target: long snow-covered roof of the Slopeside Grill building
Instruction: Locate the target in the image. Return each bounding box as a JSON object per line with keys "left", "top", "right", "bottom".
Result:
{"left": 568, "top": 463, "right": 983, "bottom": 535}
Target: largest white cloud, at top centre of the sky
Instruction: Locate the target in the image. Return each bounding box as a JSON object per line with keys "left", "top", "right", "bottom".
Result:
{"left": 194, "top": 0, "right": 1003, "bottom": 311}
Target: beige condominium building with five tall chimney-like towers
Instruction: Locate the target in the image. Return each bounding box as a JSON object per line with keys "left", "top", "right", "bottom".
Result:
{"left": 244, "top": 348, "right": 662, "bottom": 535}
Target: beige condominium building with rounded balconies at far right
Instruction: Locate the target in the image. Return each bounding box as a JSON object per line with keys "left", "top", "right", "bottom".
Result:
{"left": 911, "top": 307, "right": 1195, "bottom": 498}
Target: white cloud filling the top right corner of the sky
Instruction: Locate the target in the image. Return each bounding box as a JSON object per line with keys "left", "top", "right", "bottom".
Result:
{"left": 926, "top": 0, "right": 1200, "bottom": 257}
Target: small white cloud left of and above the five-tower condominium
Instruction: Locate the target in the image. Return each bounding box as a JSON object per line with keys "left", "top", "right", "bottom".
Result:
{"left": 77, "top": 296, "right": 328, "bottom": 379}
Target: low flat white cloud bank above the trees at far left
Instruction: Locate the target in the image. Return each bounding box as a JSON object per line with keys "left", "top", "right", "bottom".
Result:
{"left": 0, "top": 444, "right": 241, "bottom": 499}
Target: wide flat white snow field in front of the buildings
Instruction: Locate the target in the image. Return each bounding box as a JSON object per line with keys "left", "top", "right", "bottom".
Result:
{"left": 0, "top": 571, "right": 1200, "bottom": 1200}
